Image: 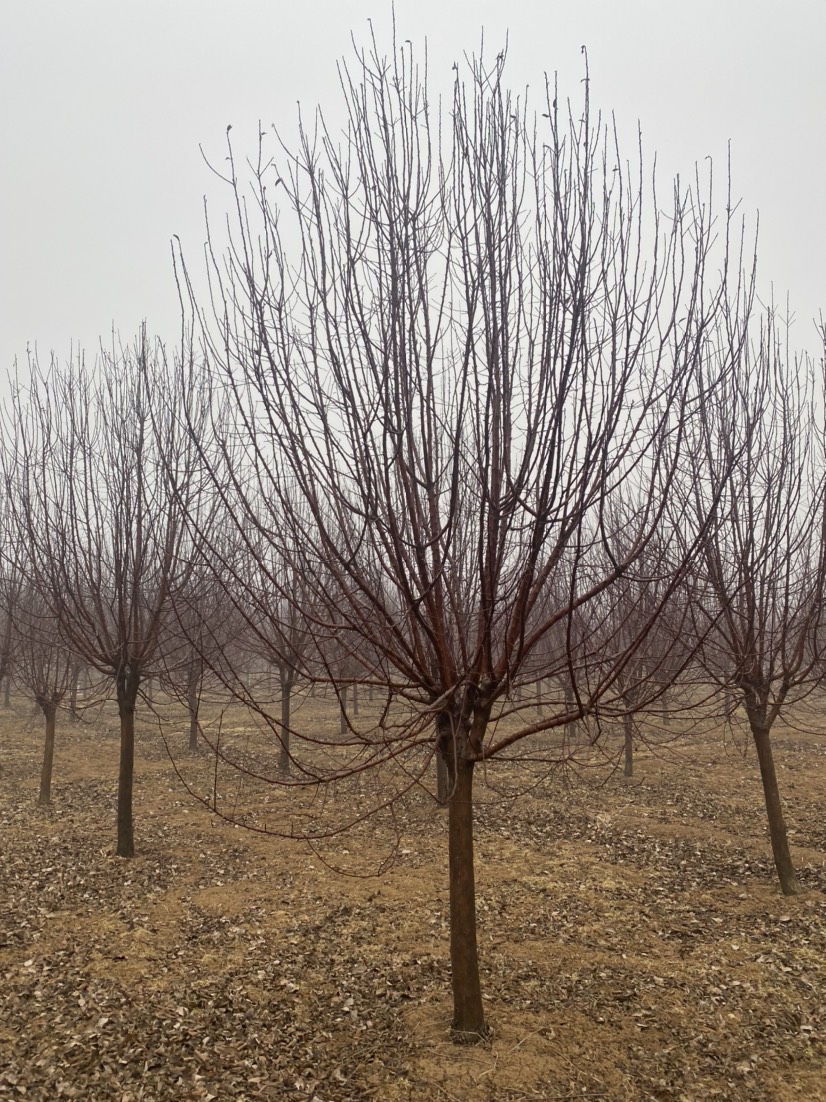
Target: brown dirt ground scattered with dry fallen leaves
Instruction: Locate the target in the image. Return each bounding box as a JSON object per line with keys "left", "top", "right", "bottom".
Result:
{"left": 0, "top": 699, "right": 826, "bottom": 1102}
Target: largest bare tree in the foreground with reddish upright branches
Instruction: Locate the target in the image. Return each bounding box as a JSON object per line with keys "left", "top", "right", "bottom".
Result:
{"left": 177, "top": 38, "right": 748, "bottom": 1039}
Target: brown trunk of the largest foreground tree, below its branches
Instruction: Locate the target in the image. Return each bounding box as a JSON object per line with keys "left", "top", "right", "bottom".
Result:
{"left": 448, "top": 758, "right": 487, "bottom": 1042}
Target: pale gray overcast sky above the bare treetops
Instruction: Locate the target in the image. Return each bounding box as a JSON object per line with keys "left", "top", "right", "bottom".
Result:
{"left": 0, "top": 0, "right": 826, "bottom": 374}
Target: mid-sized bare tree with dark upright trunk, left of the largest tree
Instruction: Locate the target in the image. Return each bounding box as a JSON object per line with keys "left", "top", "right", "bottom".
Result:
{"left": 7, "top": 333, "right": 202, "bottom": 857}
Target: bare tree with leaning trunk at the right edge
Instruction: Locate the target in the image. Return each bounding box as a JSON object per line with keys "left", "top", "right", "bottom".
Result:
{"left": 672, "top": 311, "right": 826, "bottom": 895}
